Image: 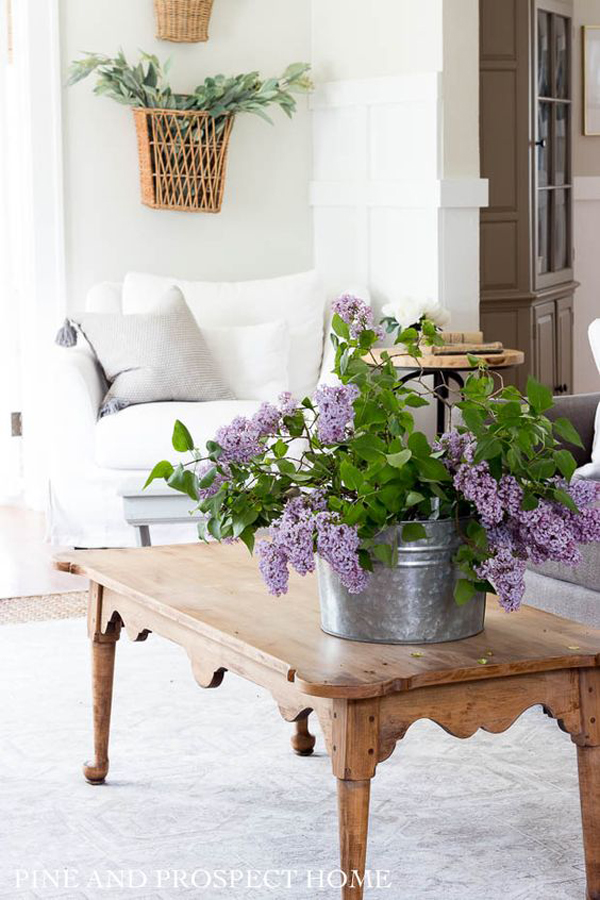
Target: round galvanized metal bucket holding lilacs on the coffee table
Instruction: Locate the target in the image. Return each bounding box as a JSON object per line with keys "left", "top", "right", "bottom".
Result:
{"left": 317, "top": 519, "right": 485, "bottom": 644}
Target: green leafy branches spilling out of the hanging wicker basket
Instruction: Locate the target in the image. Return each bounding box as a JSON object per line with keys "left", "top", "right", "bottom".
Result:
{"left": 68, "top": 50, "right": 312, "bottom": 122}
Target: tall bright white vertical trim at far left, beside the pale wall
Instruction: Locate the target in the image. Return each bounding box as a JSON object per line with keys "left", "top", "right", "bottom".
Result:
{"left": 13, "top": 0, "right": 66, "bottom": 509}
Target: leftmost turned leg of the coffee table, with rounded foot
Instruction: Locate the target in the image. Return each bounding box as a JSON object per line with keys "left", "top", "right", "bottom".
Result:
{"left": 83, "top": 634, "right": 118, "bottom": 784}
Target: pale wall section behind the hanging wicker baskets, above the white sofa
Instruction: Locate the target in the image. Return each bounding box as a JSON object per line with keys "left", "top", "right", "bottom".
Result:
{"left": 60, "top": 0, "right": 312, "bottom": 309}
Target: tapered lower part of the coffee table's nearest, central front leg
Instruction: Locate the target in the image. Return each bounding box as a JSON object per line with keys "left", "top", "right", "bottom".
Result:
{"left": 338, "top": 778, "right": 371, "bottom": 900}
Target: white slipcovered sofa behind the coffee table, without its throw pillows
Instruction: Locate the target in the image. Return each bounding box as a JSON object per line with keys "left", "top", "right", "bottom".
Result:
{"left": 48, "top": 272, "right": 344, "bottom": 547}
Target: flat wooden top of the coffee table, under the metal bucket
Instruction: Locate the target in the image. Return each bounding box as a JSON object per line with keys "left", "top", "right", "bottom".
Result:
{"left": 55, "top": 543, "right": 600, "bottom": 699}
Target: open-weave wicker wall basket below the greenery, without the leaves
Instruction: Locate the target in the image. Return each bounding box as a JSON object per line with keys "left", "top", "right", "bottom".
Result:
{"left": 133, "top": 108, "right": 233, "bottom": 213}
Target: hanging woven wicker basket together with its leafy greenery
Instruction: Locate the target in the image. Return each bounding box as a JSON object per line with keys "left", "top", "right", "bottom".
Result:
{"left": 69, "top": 51, "right": 311, "bottom": 213}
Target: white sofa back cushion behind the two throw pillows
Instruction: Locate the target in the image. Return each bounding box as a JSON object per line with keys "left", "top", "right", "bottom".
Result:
{"left": 123, "top": 271, "right": 326, "bottom": 398}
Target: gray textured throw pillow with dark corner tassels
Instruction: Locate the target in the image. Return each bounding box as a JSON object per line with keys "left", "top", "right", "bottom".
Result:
{"left": 62, "top": 287, "right": 234, "bottom": 416}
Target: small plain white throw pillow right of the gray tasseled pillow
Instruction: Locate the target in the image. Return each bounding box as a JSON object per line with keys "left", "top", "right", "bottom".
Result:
{"left": 200, "top": 321, "right": 290, "bottom": 401}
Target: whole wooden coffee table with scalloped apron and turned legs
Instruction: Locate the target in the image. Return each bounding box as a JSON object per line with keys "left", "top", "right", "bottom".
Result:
{"left": 56, "top": 544, "right": 600, "bottom": 900}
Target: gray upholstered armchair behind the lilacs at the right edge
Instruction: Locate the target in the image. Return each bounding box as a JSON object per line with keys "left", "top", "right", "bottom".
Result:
{"left": 524, "top": 394, "right": 600, "bottom": 627}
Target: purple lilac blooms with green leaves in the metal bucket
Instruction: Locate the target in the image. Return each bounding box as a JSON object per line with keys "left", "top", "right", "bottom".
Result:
{"left": 147, "top": 295, "right": 600, "bottom": 612}
